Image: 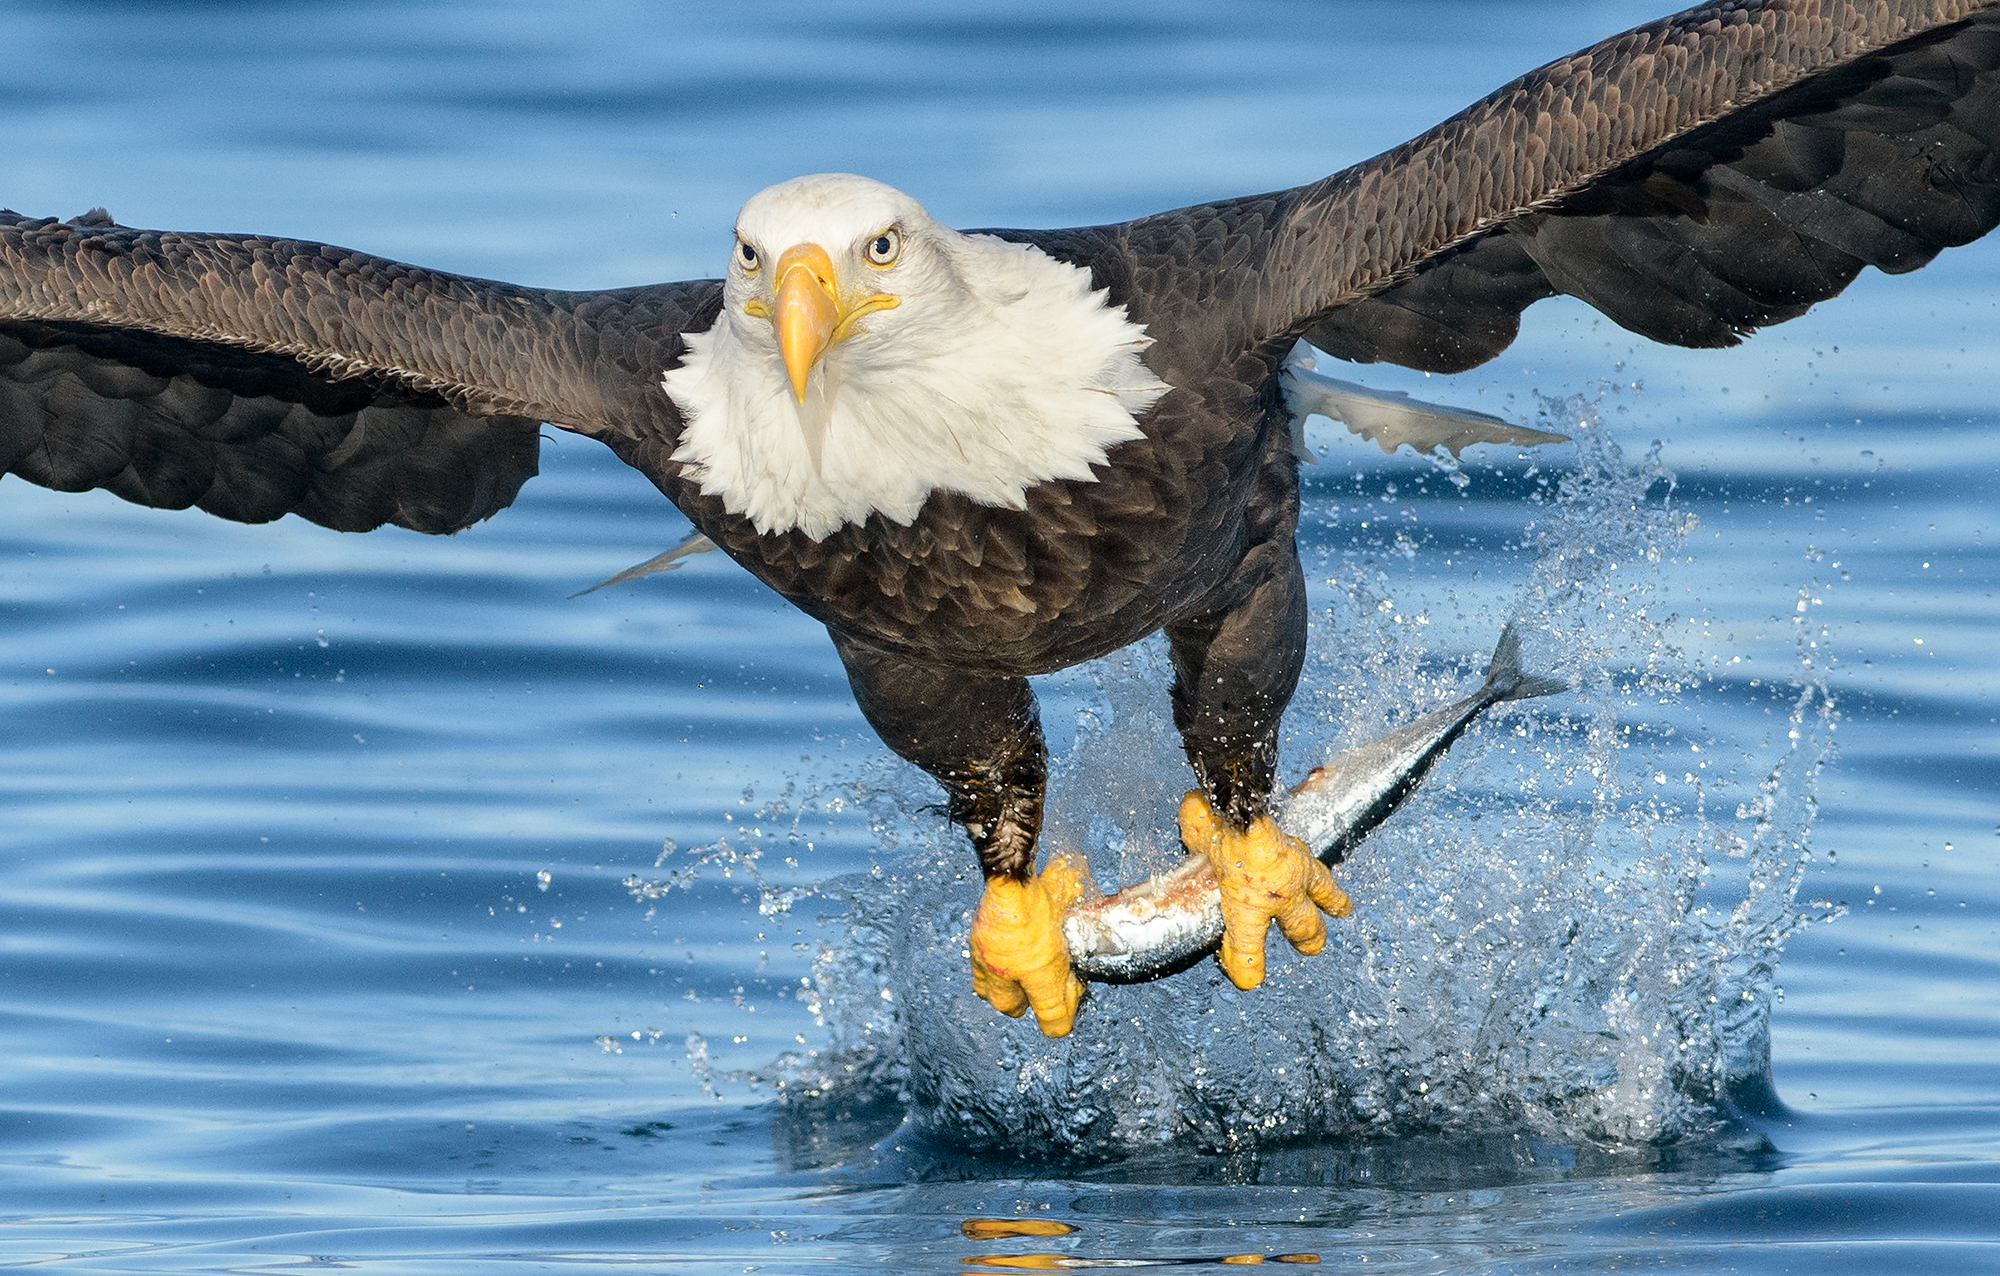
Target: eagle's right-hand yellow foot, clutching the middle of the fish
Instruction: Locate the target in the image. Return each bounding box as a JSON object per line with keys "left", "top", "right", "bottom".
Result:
{"left": 1180, "top": 790, "right": 1352, "bottom": 988}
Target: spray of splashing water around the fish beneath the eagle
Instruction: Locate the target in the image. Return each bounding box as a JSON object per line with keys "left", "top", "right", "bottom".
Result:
{"left": 770, "top": 400, "right": 1834, "bottom": 1154}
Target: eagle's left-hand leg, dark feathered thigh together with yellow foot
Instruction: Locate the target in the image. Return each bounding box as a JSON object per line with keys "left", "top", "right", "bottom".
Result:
{"left": 834, "top": 632, "right": 1086, "bottom": 1036}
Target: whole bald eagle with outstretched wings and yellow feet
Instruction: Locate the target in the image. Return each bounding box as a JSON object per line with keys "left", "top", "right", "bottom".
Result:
{"left": 0, "top": 0, "right": 2000, "bottom": 1036}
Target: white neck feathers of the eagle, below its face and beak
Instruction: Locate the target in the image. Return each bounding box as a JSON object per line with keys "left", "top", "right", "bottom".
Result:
{"left": 662, "top": 228, "right": 1168, "bottom": 540}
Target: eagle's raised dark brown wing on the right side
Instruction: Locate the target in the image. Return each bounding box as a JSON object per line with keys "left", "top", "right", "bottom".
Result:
{"left": 1106, "top": 0, "right": 2000, "bottom": 372}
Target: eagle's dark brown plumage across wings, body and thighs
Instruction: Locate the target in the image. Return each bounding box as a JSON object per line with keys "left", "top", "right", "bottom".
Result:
{"left": 0, "top": 0, "right": 2000, "bottom": 1016}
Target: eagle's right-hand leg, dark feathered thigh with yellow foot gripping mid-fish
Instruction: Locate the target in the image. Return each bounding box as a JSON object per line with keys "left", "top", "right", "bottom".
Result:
{"left": 1166, "top": 488, "right": 1350, "bottom": 988}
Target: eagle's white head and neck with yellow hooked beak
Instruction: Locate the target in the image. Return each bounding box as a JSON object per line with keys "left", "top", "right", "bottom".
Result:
{"left": 662, "top": 174, "right": 1166, "bottom": 540}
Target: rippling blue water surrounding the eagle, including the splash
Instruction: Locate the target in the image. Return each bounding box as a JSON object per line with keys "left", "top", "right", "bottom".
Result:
{"left": 0, "top": 0, "right": 2000, "bottom": 1274}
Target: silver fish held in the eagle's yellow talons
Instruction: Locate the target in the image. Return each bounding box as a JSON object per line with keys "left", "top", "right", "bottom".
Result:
{"left": 1062, "top": 624, "right": 1568, "bottom": 984}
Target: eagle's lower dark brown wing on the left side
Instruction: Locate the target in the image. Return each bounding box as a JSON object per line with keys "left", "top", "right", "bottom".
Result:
{"left": 0, "top": 210, "right": 720, "bottom": 532}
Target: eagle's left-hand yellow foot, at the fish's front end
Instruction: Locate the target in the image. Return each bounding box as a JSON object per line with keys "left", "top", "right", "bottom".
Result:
{"left": 972, "top": 856, "right": 1086, "bottom": 1036}
